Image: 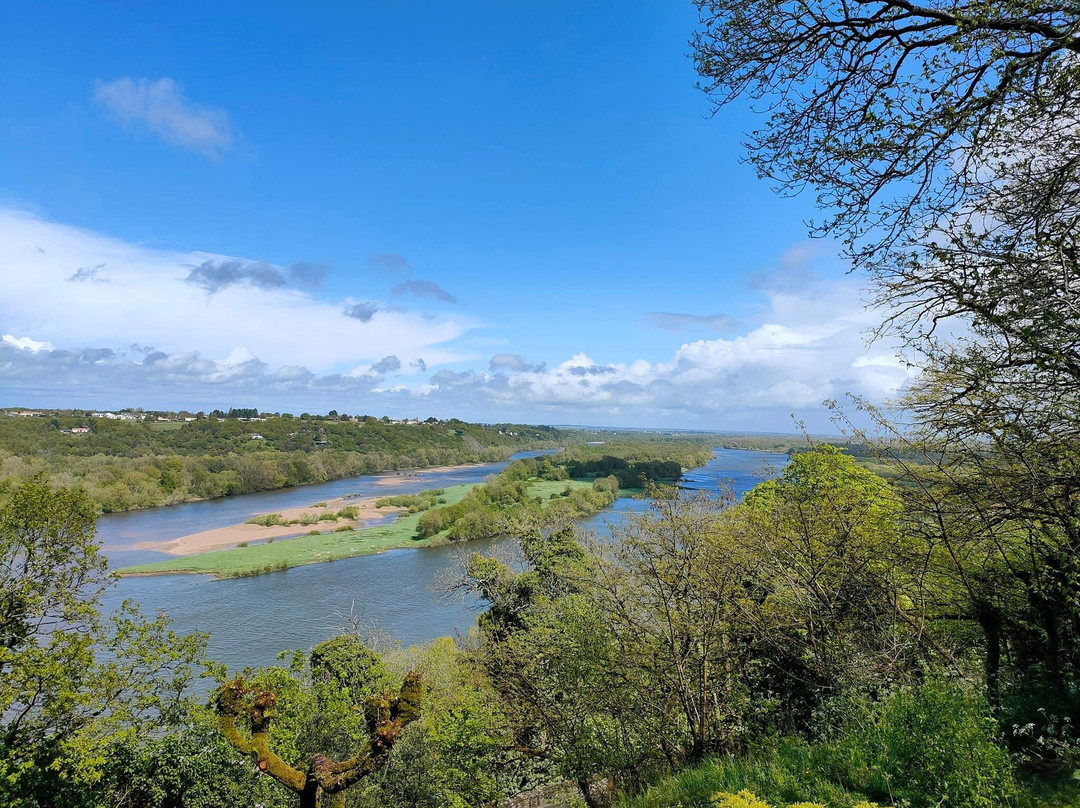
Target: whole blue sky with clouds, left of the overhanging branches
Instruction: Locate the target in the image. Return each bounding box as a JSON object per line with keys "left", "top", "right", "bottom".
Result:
{"left": 0, "top": 0, "right": 913, "bottom": 432}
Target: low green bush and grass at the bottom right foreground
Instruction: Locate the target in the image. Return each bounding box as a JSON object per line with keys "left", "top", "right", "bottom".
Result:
{"left": 623, "top": 679, "right": 1015, "bottom": 808}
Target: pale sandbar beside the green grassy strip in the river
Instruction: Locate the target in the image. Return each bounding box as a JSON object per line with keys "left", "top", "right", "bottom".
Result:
{"left": 136, "top": 494, "right": 406, "bottom": 555}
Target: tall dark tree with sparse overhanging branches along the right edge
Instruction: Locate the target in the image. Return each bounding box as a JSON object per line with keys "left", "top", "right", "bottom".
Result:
{"left": 694, "top": 0, "right": 1080, "bottom": 743}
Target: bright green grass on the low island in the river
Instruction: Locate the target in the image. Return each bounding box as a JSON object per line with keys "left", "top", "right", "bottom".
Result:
{"left": 118, "top": 480, "right": 600, "bottom": 578}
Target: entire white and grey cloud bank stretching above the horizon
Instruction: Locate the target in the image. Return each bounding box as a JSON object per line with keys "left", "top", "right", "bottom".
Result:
{"left": 0, "top": 210, "right": 914, "bottom": 429}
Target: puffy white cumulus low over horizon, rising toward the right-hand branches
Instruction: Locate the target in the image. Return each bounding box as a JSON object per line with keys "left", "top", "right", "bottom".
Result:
{"left": 418, "top": 279, "right": 916, "bottom": 429}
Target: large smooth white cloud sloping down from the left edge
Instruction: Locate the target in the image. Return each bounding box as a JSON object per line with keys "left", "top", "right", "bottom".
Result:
{"left": 0, "top": 208, "right": 475, "bottom": 378}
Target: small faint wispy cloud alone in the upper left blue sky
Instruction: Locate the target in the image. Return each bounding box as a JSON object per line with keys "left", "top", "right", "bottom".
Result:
{"left": 94, "top": 77, "right": 234, "bottom": 160}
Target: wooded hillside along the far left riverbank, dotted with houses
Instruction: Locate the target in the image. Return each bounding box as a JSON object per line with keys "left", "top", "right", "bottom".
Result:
{"left": 0, "top": 418, "right": 566, "bottom": 512}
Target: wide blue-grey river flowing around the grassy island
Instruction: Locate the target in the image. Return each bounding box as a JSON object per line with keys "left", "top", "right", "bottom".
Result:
{"left": 97, "top": 449, "right": 786, "bottom": 669}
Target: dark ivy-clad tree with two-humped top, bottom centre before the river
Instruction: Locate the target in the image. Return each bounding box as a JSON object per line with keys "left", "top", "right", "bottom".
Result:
{"left": 467, "top": 529, "right": 656, "bottom": 807}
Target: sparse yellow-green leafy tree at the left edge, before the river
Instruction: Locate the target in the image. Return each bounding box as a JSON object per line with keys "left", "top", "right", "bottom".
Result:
{"left": 0, "top": 480, "right": 203, "bottom": 808}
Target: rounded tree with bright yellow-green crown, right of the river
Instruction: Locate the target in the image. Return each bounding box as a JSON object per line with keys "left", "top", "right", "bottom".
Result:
{"left": 731, "top": 444, "right": 924, "bottom": 708}
